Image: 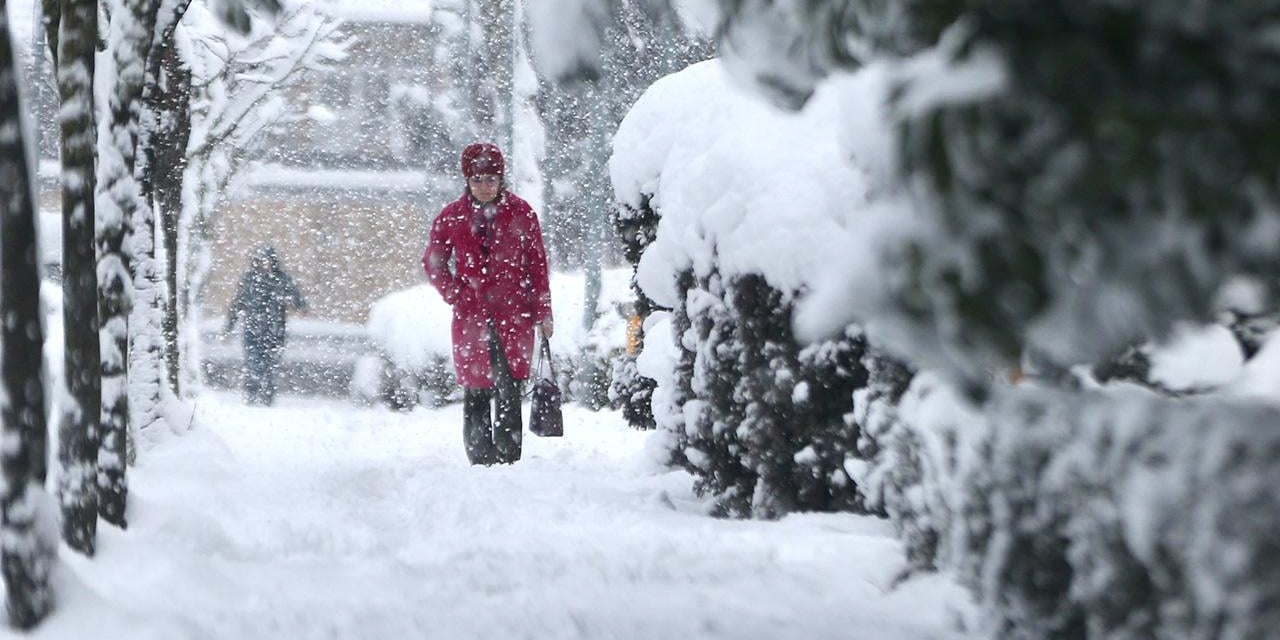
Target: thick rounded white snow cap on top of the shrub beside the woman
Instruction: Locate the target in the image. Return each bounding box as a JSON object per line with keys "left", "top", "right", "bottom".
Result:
{"left": 609, "top": 60, "right": 867, "bottom": 307}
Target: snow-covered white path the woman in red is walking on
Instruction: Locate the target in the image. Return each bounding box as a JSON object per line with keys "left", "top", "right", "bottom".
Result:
{"left": 28, "top": 394, "right": 961, "bottom": 640}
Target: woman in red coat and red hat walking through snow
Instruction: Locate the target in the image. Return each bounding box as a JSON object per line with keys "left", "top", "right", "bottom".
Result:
{"left": 422, "top": 143, "right": 553, "bottom": 465}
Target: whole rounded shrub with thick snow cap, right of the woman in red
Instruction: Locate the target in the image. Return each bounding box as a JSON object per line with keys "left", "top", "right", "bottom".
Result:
{"left": 611, "top": 60, "right": 865, "bottom": 517}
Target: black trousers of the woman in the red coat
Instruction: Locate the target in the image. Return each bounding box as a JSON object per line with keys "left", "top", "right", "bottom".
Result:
{"left": 462, "top": 323, "right": 525, "bottom": 465}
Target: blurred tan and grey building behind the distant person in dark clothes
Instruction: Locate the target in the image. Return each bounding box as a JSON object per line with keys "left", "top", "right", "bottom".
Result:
{"left": 204, "top": 3, "right": 466, "bottom": 323}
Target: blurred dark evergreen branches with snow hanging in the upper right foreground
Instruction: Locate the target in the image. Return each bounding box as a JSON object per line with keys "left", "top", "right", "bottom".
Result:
{"left": 722, "top": 0, "right": 1280, "bottom": 392}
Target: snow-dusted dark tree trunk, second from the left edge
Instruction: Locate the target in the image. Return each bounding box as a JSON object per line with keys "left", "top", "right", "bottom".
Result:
{"left": 58, "top": 0, "right": 102, "bottom": 556}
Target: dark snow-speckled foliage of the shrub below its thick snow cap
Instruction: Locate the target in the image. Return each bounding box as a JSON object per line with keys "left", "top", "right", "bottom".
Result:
{"left": 657, "top": 273, "right": 867, "bottom": 518}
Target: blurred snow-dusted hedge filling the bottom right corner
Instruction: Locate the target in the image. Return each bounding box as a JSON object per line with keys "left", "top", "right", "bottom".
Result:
{"left": 852, "top": 340, "right": 1280, "bottom": 639}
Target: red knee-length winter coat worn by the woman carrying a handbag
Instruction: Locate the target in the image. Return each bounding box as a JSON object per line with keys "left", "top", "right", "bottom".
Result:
{"left": 422, "top": 193, "right": 552, "bottom": 388}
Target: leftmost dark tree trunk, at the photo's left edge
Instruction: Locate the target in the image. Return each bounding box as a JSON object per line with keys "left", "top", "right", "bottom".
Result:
{"left": 0, "top": 0, "right": 58, "bottom": 628}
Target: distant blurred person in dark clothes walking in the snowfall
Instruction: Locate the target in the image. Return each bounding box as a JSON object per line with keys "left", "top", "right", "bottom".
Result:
{"left": 223, "top": 244, "right": 307, "bottom": 404}
